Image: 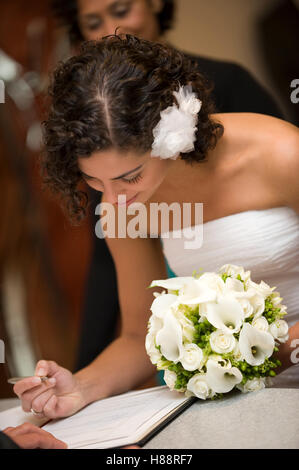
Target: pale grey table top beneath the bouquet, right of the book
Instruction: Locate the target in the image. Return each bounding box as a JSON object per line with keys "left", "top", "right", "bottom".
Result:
{"left": 0, "top": 388, "right": 299, "bottom": 449}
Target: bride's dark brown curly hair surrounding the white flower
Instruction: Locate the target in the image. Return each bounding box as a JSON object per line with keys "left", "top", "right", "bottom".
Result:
{"left": 41, "top": 35, "right": 223, "bottom": 223}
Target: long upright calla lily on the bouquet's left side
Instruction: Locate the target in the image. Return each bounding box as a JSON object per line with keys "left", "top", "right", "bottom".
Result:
{"left": 156, "top": 310, "right": 183, "bottom": 364}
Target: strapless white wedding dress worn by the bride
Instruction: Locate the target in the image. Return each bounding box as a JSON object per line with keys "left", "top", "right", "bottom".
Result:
{"left": 161, "top": 207, "right": 299, "bottom": 388}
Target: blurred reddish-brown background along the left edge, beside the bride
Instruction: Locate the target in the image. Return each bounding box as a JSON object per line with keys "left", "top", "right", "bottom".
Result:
{"left": 0, "top": 0, "right": 91, "bottom": 398}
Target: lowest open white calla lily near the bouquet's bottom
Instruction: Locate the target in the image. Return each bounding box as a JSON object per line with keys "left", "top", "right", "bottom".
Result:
{"left": 206, "top": 359, "right": 243, "bottom": 393}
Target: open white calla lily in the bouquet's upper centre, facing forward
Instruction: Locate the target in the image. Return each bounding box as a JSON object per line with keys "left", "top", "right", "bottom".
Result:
{"left": 206, "top": 296, "right": 244, "bottom": 334}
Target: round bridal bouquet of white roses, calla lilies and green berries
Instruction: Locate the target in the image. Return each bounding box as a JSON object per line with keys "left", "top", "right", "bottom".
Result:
{"left": 145, "top": 264, "right": 288, "bottom": 400}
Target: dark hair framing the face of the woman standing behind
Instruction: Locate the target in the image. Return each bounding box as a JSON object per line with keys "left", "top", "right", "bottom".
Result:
{"left": 51, "top": 0, "right": 175, "bottom": 45}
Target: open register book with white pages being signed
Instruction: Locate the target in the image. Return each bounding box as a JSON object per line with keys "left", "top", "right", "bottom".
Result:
{"left": 0, "top": 386, "right": 196, "bottom": 449}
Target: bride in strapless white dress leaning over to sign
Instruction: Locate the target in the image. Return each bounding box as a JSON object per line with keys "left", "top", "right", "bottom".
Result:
{"left": 14, "top": 35, "right": 299, "bottom": 418}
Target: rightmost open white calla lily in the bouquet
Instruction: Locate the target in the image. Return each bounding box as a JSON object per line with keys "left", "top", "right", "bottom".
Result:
{"left": 239, "top": 323, "right": 275, "bottom": 366}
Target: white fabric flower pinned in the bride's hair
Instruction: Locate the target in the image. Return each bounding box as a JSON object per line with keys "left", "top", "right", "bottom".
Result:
{"left": 151, "top": 85, "right": 202, "bottom": 160}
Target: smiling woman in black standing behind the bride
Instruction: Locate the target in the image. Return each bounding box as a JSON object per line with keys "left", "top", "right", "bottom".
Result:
{"left": 52, "top": 0, "right": 283, "bottom": 370}
